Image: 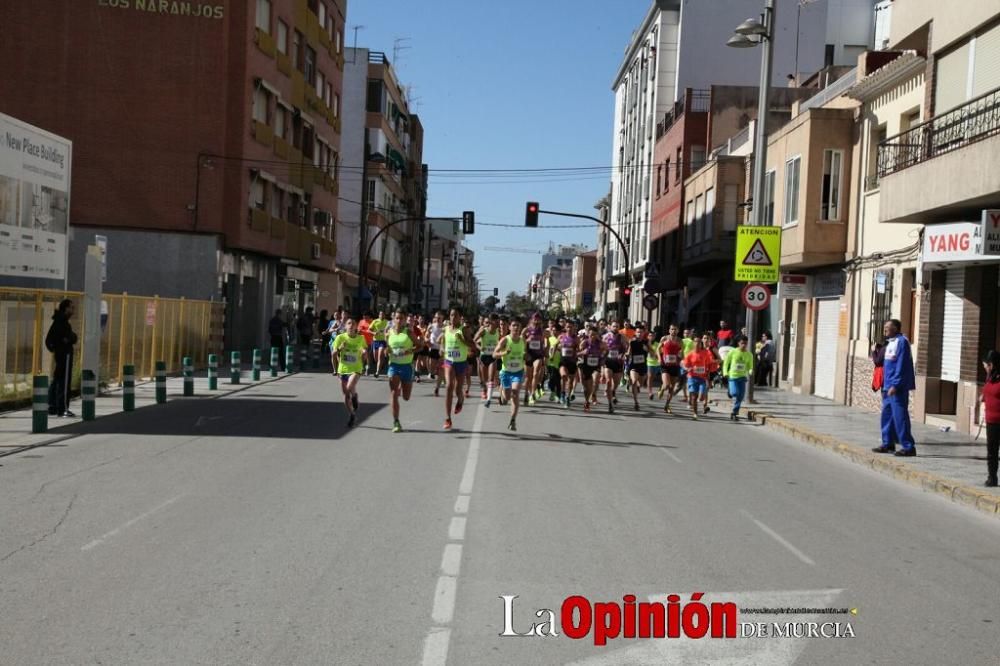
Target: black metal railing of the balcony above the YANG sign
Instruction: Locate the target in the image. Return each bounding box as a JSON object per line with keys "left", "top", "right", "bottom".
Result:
{"left": 878, "top": 88, "right": 1000, "bottom": 178}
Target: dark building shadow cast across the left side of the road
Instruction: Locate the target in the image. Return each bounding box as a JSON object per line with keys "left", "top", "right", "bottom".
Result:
{"left": 49, "top": 397, "right": 387, "bottom": 439}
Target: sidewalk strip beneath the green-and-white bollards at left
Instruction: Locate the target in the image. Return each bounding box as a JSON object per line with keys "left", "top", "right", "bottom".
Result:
{"left": 0, "top": 369, "right": 294, "bottom": 457}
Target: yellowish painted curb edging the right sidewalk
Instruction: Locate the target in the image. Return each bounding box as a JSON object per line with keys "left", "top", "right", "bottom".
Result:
{"left": 744, "top": 410, "right": 1000, "bottom": 518}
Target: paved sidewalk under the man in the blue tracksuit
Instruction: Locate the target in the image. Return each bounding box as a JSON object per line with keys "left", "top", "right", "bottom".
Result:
{"left": 744, "top": 388, "right": 1000, "bottom": 517}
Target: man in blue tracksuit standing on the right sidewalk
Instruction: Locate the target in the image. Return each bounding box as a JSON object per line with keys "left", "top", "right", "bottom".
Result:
{"left": 872, "top": 319, "right": 917, "bottom": 456}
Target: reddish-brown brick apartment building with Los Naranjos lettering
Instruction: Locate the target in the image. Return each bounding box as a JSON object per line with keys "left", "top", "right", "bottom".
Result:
{"left": 0, "top": 0, "right": 347, "bottom": 349}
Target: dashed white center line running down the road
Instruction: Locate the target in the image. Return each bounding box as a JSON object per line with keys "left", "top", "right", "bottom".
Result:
{"left": 420, "top": 405, "right": 486, "bottom": 666}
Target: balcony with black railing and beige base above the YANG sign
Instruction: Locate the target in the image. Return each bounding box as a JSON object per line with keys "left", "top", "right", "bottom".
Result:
{"left": 878, "top": 89, "right": 1000, "bottom": 224}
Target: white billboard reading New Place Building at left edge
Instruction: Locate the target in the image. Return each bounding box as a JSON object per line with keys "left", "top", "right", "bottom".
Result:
{"left": 0, "top": 113, "right": 73, "bottom": 280}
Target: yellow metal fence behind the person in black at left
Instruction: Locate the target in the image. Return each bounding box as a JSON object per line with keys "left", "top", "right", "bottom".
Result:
{"left": 0, "top": 287, "right": 225, "bottom": 404}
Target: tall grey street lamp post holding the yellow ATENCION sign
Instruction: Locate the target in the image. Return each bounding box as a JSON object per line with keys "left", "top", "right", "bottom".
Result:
{"left": 726, "top": 0, "right": 775, "bottom": 403}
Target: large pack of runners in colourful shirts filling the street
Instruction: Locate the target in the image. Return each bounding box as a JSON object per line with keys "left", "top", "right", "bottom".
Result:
{"left": 327, "top": 310, "right": 754, "bottom": 432}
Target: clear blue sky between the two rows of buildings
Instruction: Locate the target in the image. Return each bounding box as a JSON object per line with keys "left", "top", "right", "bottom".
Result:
{"left": 345, "top": 0, "right": 650, "bottom": 296}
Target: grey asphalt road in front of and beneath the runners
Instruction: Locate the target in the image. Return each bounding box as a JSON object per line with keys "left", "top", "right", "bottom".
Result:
{"left": 0, "top": 374, "right": 1000, "bottom": 665}
